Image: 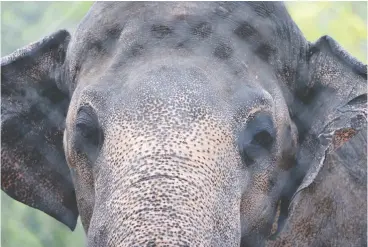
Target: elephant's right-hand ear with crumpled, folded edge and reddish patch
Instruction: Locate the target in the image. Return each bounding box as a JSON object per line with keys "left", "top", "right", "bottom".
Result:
{"left": 291, "top": 36, "right": 367, "bottom": 207}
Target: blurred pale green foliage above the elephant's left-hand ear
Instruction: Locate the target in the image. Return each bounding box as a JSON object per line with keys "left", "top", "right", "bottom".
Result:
{"left": 1, "top": 2, "right": 92, "bottom": 56}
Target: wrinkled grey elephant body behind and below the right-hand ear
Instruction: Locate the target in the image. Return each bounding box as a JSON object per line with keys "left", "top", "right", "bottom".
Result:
{"left": 266, "top": 121, "right": 367, "bottom": 247}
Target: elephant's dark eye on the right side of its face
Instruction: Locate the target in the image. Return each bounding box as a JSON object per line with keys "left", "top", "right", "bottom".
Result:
{"left": 238, "top": 112, "right": 276, "bottom": 166}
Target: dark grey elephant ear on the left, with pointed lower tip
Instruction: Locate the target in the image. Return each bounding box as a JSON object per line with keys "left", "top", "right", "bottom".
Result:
{"left": 1, "top": 30, "right": 78, "bottom": 230}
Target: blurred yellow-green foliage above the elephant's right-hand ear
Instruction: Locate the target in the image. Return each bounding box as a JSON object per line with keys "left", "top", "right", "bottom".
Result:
{"left": 287, "top": 2, "right": 367, "bottom": 63}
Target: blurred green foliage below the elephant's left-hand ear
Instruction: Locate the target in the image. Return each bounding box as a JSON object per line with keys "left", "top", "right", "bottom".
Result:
{"left": 1, "top": 192, "right": 85, "bottom": 247}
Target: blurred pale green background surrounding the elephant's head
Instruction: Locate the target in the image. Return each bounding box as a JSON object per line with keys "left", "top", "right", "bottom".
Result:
{"left": 1, "top": 2, "right": 367, "bottom": 247}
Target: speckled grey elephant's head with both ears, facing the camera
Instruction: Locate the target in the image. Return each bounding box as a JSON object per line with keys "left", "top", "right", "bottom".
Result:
{"left": 1, "top": 2, "right": 367, "bottom": 247}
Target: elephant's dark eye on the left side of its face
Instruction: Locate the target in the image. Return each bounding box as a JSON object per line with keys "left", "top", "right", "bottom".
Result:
{"left": 75, "top": 106, "right": 103, "bottom": 162}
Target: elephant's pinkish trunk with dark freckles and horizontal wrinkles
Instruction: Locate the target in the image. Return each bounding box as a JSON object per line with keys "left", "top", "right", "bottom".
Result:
{"left": 88, "top": 154, "right": 240, "bottom": 247}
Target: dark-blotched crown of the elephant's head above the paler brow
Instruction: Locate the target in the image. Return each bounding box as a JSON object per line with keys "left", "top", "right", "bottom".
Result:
{"left": 67, "top": 3, "right": 288, "bottom": 96}
